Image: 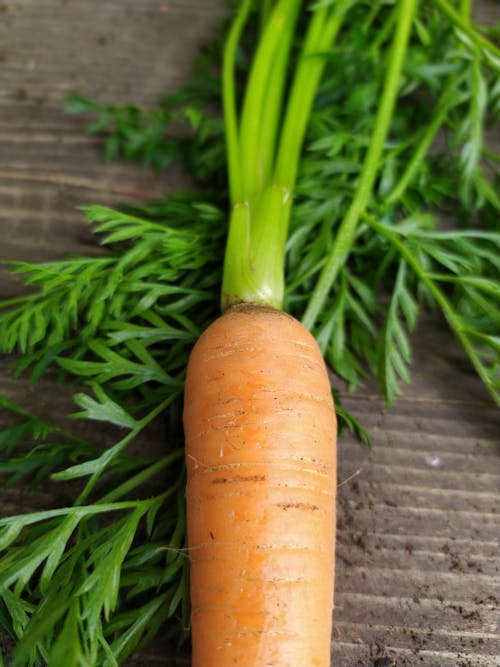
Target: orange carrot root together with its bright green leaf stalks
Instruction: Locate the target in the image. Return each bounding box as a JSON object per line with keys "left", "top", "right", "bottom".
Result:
{"left": 184, "top": 0, "right": 415, "bottom": 667}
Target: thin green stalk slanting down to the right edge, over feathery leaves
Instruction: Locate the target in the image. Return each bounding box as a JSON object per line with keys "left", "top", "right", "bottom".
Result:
{"left": 363, "top": 213, "right": 500, "bottom": 404}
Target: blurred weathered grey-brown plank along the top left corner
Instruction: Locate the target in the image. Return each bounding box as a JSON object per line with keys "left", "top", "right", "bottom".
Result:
{"left": 0, "top": 0, "right": 223, "bottom": 107}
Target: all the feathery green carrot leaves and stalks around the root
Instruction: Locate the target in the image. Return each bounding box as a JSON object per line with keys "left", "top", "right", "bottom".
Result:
{"left": 0, "top": 0, "right": 500, "bottom": 667}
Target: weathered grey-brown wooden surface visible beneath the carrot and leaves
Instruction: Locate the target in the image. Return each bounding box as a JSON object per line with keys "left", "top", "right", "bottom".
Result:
{"left": 0, "top": 0, "right": 500, "bottom": 667}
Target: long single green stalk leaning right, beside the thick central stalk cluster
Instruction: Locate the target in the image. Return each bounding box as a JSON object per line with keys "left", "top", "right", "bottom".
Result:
{"left": 302, "top": 0, "right": 417, "bottom": 329}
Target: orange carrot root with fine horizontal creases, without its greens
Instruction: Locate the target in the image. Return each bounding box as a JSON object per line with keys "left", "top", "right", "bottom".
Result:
{"left": 184, "top": 305, "right": 336, "bottom": 667}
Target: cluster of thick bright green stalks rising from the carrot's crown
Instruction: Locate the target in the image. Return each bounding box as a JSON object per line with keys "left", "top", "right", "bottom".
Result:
{"left": 221, "top": 0, "right": 350, "bottom": 311}
